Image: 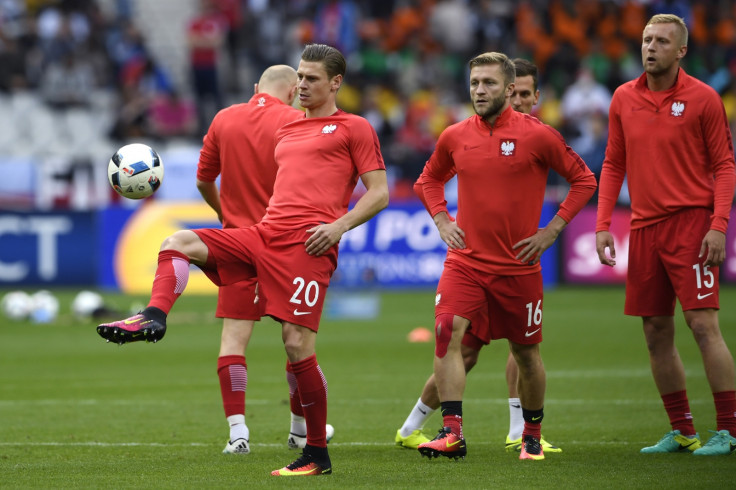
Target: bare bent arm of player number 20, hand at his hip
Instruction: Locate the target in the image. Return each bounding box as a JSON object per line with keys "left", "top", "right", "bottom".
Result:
{"left": 305, "top": 170, "right": 388, "bottom": 255}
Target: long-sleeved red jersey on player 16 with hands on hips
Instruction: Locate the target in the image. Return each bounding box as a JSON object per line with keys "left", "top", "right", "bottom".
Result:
{"left": 414, "top": 107, "right": 596, "bottom": 275}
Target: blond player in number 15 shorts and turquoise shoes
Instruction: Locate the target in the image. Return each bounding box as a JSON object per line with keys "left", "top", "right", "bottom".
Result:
{"left": 596, "top": 14, "right": 736, "bottom": 455}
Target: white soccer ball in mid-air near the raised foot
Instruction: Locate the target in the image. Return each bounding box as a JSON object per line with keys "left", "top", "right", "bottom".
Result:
{"left": 107, "top": 143, "right": 164, "bottom": 199}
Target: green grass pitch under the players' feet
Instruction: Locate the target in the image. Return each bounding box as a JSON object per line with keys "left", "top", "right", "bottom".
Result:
{"left": 0, "top": 287, "right": 736, "bottom": 489}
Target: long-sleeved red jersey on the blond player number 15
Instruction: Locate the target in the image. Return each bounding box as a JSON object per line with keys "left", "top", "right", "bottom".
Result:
{"left": 596, "top": 68, "right": 736, "bottom": 233}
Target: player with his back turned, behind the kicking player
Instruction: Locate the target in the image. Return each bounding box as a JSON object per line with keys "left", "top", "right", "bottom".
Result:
{"left": 197, "top": 65, "right": 333, "bottom": 454}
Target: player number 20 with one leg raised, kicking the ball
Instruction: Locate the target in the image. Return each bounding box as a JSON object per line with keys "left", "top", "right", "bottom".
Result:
{"left": 98, "top": 44, "right": 388, "bottom": 476}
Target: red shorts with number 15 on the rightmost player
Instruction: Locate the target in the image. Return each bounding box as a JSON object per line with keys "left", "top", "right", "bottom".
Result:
{"left": 624, "top": 208, "right": 719, "bottom": 316}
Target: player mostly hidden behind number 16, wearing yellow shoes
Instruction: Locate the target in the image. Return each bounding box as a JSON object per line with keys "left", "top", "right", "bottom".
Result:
{"left": 395, "top": 58, "right": 562, "bottom": 452}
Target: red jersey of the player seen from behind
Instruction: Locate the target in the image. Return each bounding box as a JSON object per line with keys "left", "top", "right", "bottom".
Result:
{"left": 197, "top": 93, "right": 304, "bottom": 228}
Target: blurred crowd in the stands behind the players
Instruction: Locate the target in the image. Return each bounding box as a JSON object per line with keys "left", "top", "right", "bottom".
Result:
{"left": 0, "top": 0, "right": 736, "bottom": 207}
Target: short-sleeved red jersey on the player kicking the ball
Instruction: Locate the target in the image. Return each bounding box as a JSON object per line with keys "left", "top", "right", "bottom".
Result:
{"left": 263, "top": 110, "right": 386, "bottom": 229}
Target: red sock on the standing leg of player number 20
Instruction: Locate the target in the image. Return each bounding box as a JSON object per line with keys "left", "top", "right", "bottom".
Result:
{"left": 289, "top": 354, "right": 327, "bottom": 447}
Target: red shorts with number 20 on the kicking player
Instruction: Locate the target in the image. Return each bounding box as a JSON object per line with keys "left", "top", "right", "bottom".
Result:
{"left": 192, "top": 223, "right": 337, "bottom": 332}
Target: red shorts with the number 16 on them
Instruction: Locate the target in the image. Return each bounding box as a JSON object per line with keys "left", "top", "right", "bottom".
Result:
{"left": 435, "top": 261, "right": 544, "bottom": 349}
